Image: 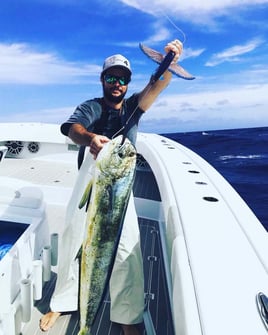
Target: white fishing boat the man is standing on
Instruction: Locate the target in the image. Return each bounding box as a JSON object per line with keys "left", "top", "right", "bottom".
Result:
{"left": 0, "top": 123, "right": 268, "bottom": 335}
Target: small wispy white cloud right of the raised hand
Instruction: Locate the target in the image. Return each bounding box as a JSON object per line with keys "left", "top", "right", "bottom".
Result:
{"left": 205, "top": 39, "right": 262, "bottom": 66}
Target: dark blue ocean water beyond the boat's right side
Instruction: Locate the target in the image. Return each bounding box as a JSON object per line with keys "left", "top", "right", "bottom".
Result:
{"left": 164, "top": 127, "right": 268, "bottom": 231}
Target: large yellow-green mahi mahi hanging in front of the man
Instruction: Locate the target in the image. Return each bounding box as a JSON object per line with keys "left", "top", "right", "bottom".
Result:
{"left": 79, "top": 136, "right": 136, "bottom": 335}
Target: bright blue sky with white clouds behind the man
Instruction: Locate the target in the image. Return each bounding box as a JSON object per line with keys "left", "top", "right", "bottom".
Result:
{"left": 0, "top": 0, "right": 268, "bottom": 133}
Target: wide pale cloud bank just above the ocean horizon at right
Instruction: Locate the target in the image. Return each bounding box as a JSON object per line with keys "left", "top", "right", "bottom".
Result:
{"left": 142, "top": 84, "right": 268, "bottom": 132}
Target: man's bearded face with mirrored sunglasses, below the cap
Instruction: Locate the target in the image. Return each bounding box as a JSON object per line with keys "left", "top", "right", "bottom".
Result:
{"left": 102, "top": 67, "right": 129, "bottom": 103}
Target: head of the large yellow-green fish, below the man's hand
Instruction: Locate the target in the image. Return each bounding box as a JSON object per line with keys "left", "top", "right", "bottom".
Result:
{"left": 96, "top": 135, "right": 137, "bottom": 178}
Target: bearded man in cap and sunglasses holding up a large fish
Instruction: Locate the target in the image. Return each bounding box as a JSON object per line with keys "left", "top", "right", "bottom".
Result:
{"left": 40, "top": 40, "right": 182, "bottom": 335}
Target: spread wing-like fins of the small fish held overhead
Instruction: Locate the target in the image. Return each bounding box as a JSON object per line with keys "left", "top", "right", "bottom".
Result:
{"left": 140, "top": 43, "right": 195, "bottom": 80}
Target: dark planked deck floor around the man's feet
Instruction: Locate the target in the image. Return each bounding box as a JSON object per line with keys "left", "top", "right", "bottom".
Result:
{"left": 22, "top": 219, "right": 174, "bottom": 335}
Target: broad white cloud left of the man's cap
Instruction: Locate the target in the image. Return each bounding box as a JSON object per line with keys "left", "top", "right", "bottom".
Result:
{"left": 0, "top": 43, "right": 101, "bottom": 84}
